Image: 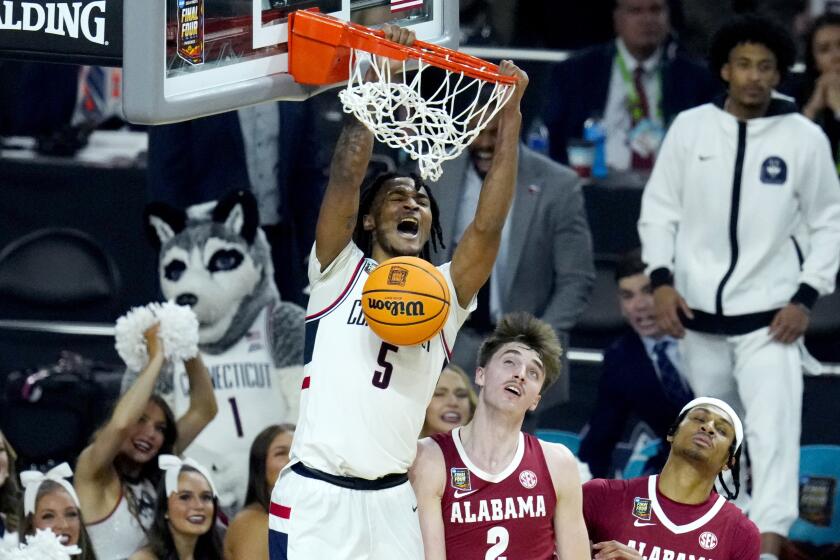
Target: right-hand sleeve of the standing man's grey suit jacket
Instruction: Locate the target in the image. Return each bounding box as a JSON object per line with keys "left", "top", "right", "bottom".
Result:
{"left": 541, "top": 177, "right": 595, "bottom": 332}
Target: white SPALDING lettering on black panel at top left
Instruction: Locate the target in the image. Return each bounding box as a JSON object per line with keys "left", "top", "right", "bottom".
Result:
{"left": 0, "top": 0, "right": 108, "bottom": 45}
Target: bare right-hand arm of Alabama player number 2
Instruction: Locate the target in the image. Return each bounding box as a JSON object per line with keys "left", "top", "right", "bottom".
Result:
{"left": 541, "top": 442, "right": 589, "bottom": 560}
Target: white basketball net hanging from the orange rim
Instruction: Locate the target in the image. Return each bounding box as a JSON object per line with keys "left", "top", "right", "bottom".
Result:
{"left": 339, "top": 49, "right": 513, "bottom": 181}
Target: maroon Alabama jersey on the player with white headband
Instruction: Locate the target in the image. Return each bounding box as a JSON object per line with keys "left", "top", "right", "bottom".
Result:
{"left": 583, "top": 476, "right": 761, "bottom": 560}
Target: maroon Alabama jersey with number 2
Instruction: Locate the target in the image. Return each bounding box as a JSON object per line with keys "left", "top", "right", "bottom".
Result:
{"left": 432, "top": 428, "right": 557, "bottom": 560}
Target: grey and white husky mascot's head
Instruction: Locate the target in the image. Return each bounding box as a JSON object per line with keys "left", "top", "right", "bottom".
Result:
{"left": 144, "top": 191, "right": 279, "bottom": 352}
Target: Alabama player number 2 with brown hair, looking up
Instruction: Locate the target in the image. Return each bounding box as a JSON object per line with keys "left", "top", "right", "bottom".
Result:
{"left": 409, "top": 313, "right": 589, "bottom": 560}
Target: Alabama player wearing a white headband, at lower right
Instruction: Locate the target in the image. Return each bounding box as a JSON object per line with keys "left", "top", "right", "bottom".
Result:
{"left": 583, "top": 397, "right": 761, "bottom": 560}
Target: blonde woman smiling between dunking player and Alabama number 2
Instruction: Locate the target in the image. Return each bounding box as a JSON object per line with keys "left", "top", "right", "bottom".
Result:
{"left": 420, "top": 364, "right": 478, "bottom": 438}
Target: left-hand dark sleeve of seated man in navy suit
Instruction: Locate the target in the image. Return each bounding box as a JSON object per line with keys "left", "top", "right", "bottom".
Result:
{"left": 579, "top": 350, "right": 630, "bottom": 478}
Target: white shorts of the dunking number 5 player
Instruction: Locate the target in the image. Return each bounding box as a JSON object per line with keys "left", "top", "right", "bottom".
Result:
{"left": 268, "top": 467, "right": 423, "bottom": 560}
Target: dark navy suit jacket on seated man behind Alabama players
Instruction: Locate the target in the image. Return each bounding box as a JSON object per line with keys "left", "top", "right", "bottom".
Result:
{"left": 578, "top": 331, "right": 685, "bottom": 478}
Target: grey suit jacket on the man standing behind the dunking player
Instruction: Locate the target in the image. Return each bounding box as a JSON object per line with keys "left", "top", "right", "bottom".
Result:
{"left": 431, "top": 145, "right": 595, "bottom": 409}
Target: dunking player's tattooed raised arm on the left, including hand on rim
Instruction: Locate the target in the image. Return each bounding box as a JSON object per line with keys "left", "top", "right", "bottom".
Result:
{"left": 315, "top": 25, "right": 415, "bottom": 271}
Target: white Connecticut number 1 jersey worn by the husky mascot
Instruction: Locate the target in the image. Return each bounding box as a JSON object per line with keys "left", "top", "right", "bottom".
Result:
{"left": 174, "top": 307, "right": 292, "bottom": 509}
